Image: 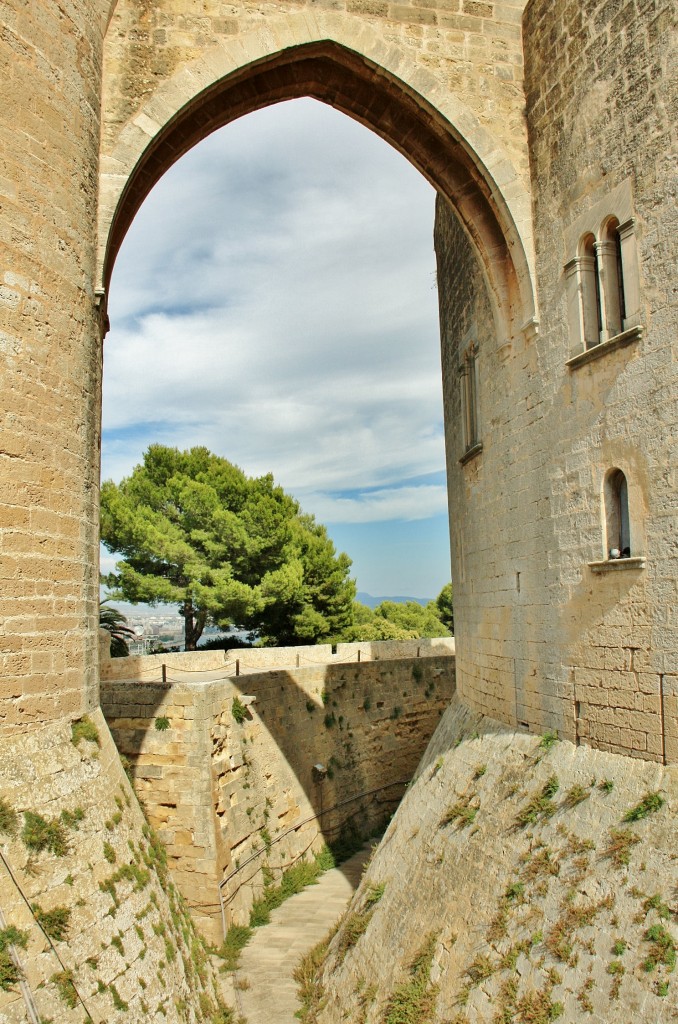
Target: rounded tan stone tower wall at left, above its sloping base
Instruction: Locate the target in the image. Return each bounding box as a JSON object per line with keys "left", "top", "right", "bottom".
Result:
{"left": 0, "top": 0, "right": 105, "bottom": 729}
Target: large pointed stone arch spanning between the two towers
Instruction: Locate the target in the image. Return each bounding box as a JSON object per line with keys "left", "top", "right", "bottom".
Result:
{"left": 98, "top": 16, "right": 537, "bottom": 344}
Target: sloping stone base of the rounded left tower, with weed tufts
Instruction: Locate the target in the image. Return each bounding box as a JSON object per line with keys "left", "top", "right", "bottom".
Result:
{"left": 0, "top": 711, "right": 231, "bottom": 1024}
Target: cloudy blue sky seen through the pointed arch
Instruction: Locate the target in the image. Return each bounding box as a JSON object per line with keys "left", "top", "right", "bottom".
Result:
{"left": 101, "top": 99, "right": 450, "bottom": 597}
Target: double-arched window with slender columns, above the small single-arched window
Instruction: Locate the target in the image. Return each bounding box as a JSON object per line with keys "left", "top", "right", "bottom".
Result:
{"left": 565, "top": 214, "right": 640, "bottom": 351}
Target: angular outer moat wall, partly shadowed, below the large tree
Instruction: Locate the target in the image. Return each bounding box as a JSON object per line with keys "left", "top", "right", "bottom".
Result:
{"left": 101, "top": 640, "right": 455, "bottom": 941}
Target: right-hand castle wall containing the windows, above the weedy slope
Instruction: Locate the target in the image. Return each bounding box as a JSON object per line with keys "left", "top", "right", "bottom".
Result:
{"left": 436, "top": 2, "right": 678, "bottom": 763}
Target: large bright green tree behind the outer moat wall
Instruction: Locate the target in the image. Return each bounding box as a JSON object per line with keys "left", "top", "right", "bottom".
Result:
{"left": 101, "top": 444, "right": 355, "bottom": 650}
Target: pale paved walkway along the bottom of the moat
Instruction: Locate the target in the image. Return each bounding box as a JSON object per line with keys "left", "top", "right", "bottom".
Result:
{"left": 236, "top": 849, "right": 370, "bottom": 1024}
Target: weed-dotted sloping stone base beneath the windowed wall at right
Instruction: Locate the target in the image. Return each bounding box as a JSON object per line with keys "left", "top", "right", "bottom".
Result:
{"left": 314, "top": 697, "right": 678, "bottom": 1024}
